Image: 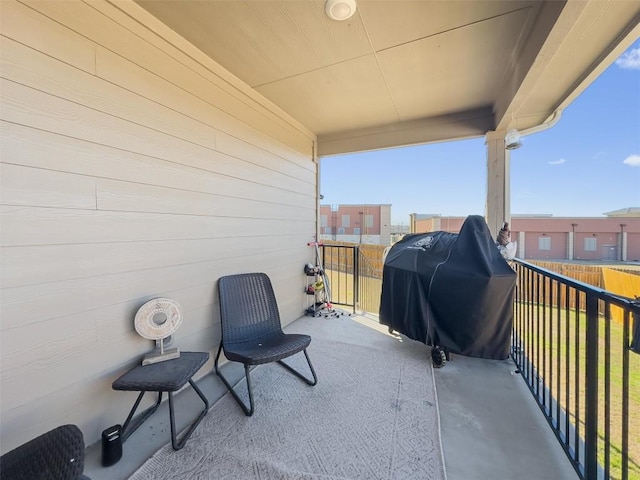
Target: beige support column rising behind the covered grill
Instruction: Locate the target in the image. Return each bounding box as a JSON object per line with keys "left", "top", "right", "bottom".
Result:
{"left": 485, "top": 130, "right": 511, "bottom": 237}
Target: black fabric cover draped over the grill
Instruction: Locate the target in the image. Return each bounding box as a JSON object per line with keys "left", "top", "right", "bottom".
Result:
{"left": 380, "top": 215, "right": 516, "bottom": 360}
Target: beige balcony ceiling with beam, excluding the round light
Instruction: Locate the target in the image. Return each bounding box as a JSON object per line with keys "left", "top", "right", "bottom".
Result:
{"left": 132, "top": 0, "right": 640, "bottom": 156}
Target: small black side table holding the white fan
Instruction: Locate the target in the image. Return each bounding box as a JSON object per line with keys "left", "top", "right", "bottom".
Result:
{"left": 111, "top": 352, "right": 209, "bottom": 450}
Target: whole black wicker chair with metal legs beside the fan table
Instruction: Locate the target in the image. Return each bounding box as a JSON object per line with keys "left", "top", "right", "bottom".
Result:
{"left": 214, "top": 273, "right": 318, "bottom": 416}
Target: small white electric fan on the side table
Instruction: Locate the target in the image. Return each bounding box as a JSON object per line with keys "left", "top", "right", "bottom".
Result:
{"left": 134, "top": 298, "right": 182, "bottom": 365}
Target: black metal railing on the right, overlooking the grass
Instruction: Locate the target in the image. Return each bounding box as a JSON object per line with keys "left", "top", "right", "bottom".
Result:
{"left": 512, "top": 260, "right": 640, "bottom": 480}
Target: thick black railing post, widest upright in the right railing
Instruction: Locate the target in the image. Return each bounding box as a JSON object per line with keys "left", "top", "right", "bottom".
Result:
{"left": 584, "top": 293, "right": 599, "bottom": 480}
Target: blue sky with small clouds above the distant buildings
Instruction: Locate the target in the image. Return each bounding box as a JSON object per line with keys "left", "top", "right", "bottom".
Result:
{"left": 320, "top": 41, "right": 640, "bottom": 225}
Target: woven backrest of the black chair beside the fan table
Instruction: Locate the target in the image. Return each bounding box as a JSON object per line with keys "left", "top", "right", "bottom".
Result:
{"left": 218, "top": 273, "right": 282, "bottom": 345}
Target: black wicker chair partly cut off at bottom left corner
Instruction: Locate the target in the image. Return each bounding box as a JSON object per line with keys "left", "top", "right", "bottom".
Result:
{"left": 0, "top": 425, "right": 89, "bottom": 480}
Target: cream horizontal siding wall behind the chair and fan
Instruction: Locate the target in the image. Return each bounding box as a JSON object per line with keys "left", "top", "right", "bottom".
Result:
{"left": 0, "top": 0, "right": 317, "bottom": 453}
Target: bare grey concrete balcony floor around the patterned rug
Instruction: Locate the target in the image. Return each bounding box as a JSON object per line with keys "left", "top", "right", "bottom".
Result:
{"left": 84, "top": 315, "right": 578, "bottom": 480}
